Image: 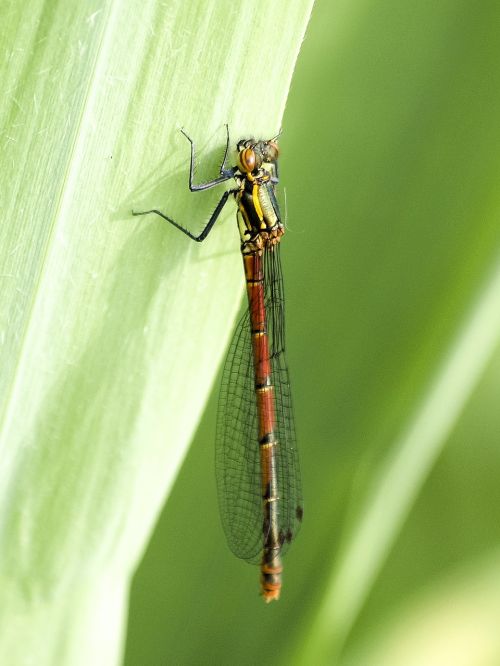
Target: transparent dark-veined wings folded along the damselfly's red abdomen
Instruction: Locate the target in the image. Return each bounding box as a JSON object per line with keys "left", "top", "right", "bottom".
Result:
{"left": 216, "top": 245, "right": 302, "bottom": 562}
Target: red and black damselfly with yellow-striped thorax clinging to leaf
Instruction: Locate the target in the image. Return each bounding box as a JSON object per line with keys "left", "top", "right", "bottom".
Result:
{"left": 134, "top": 130, "right": 303, "bottom": 601}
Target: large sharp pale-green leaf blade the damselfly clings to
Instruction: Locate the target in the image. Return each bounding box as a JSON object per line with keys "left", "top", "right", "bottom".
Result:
{"left": 0, "top": 0, "right": 312, "bottom": 666}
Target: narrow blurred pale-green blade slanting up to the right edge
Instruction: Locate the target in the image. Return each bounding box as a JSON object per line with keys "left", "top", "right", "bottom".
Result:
{"left": 300, "top": 267, "right": 500, "bottom": 663}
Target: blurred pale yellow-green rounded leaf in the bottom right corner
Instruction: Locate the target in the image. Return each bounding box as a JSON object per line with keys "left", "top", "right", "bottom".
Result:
{"left": 343, "top": 551, "right": 500, "bottom": 666}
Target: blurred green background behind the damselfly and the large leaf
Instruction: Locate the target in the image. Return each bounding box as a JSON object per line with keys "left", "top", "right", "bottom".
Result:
{"left": 125, "top": 0, "right": 500, "bottom": 666}
